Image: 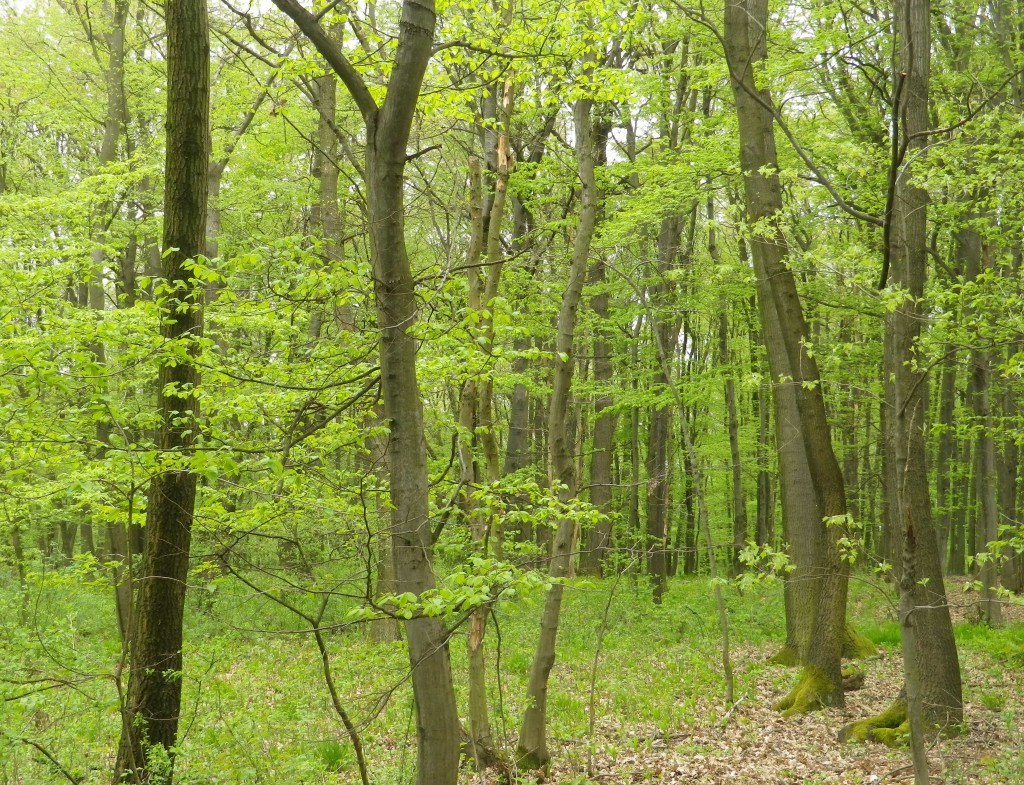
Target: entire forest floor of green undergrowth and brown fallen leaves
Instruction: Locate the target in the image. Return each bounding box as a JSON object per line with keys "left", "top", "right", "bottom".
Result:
{"left": 0, "top": 572, "right": 1024, "bottom": 785}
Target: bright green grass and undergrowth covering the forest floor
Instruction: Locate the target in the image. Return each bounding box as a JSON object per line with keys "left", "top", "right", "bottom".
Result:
{"left": 0, "top": 574, "right": 1024, "bottom": 785}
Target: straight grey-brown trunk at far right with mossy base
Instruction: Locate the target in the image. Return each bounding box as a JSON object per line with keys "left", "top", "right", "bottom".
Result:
{"left": 885, "top": 0, "right": 963, "bottom": 728}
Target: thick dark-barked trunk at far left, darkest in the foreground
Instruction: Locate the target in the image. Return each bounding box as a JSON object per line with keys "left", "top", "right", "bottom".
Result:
{"left": 114, "top": 0, "right": 210, "bottom": 783}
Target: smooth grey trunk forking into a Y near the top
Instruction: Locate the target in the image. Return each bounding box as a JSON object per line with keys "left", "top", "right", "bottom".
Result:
{"left": 264, "top": 0, "right": 459, "bottom": 785}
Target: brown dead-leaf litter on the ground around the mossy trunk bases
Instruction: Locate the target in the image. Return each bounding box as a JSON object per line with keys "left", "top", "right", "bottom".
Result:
{"left": 473, "top": 579, "right": 1024, "bottom": 785}
